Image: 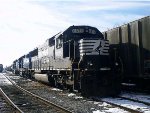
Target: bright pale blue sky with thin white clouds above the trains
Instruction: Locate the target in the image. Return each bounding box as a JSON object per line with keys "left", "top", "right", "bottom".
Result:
{"left": 0, "top": 0, "right": 150, "bottom": 66}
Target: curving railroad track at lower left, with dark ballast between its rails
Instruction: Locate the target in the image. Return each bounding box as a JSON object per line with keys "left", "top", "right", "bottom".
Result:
{"left": 2, "top": 75, "right": 72, "bottom": 113}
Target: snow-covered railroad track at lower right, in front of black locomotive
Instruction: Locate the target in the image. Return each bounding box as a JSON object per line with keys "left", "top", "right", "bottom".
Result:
{"left": 93, "top": 90, "right": 150, "bottom": 113}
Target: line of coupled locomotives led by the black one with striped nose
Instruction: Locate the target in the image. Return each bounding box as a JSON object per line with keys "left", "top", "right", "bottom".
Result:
{"left": 12, "top": 26, "right": 120, "bottom": 96}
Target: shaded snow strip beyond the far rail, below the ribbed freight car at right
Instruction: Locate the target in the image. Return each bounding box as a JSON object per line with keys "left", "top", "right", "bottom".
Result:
{"left": 121, "top": 93, "right": 150, "bottom": 103}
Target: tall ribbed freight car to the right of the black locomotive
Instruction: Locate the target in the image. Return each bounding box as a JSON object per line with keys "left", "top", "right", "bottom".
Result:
{"left": 103, "top": 16, "right": 150, "bottom": 89}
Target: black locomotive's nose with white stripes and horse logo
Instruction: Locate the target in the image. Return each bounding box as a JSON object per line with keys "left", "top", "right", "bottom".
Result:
{"left": 79, "top": 39, "right": 109, "bottom": 70}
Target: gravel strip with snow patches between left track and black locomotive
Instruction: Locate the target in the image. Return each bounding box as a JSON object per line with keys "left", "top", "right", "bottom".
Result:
{"left": 9, "top": 75, "right": 127, "bottom": 113}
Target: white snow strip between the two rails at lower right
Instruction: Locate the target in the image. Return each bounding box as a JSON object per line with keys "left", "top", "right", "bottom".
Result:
{"left": 102, "top": 98, "right": 150, "bottom": 113}
